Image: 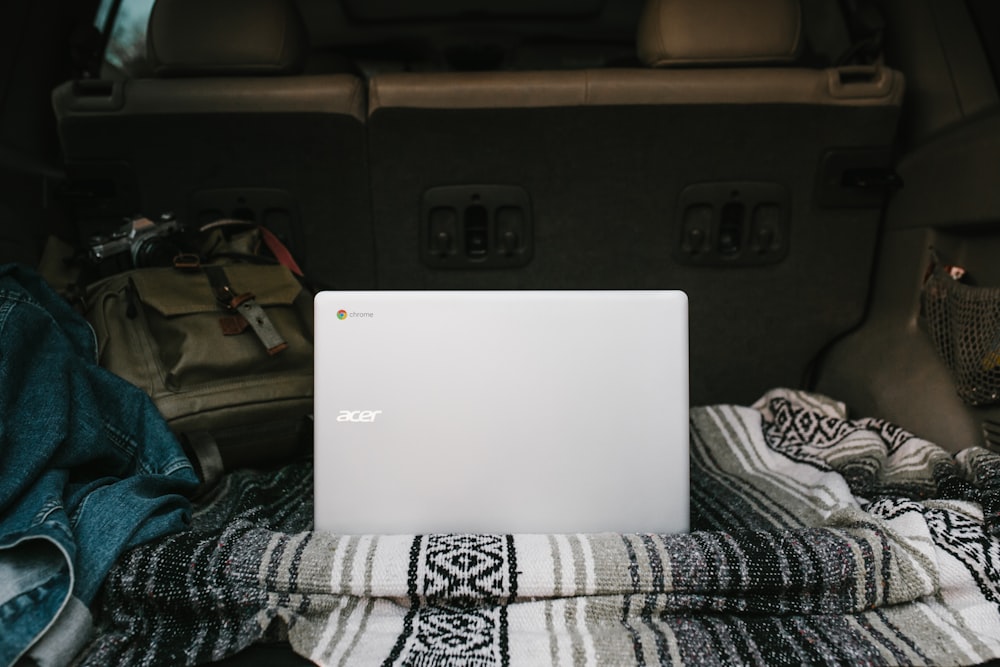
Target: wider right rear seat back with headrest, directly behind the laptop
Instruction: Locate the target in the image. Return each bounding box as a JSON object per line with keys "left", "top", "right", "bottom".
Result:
{"left": 368, "top": 0, "right": 903, "bottom": 403}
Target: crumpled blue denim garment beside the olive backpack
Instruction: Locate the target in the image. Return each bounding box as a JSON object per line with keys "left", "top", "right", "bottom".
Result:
{"left": 0, "top": 265, "right": 198, "bottom": 665}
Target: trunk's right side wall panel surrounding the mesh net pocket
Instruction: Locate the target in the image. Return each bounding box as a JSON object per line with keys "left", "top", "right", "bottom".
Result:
{"left": 817, "top": 112, "right": 1000, "bottom": 451}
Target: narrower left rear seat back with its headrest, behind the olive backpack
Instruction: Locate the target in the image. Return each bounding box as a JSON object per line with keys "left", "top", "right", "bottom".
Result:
{"left": 53, "top": 0, "right": 374, "bottom": 288}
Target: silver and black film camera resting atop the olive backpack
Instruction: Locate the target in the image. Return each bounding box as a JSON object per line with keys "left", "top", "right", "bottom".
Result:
{"left": 88, "top": 214, "right": 185, "bottom": 275}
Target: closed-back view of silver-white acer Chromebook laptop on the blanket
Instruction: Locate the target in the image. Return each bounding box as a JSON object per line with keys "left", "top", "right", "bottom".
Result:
{"left": 315, "top": 291, "right": 689, "bottom": 535}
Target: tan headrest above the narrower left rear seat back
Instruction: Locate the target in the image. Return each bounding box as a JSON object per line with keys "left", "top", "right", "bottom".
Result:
{"left": 146, "top": 0, "right": 308, "bottom": 76}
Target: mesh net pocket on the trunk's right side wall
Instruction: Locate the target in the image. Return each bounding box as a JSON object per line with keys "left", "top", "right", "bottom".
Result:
{"left": 921, "top": 265, "right": 1000, "bottom": 405}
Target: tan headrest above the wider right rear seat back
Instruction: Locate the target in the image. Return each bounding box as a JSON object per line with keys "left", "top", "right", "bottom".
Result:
{"left": 636, "top": 0, "right": 802, "bottom": 67}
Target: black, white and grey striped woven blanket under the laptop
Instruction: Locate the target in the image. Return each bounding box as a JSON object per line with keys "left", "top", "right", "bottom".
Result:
{"left": 80, "top": 390, "right": 1000, "bottom": 667}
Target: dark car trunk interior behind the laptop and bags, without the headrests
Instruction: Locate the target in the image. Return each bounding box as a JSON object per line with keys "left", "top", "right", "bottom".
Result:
{"left": 0, "top": 0, "right": 1000, "bottom": 664}
